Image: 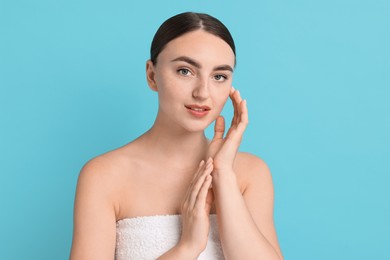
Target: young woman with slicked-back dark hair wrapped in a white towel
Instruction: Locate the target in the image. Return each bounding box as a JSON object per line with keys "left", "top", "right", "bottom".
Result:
{"left": 71, "top": 13, "right": 283, "bottom": 260}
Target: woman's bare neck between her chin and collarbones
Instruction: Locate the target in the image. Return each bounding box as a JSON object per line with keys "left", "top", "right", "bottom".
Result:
{"left": 142, "top": 112, "right": 208, "bottom": 169}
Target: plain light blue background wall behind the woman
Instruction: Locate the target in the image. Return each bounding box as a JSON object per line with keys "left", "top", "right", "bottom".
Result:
{"left": 0, "top": 0, "right": 390, "bottom": 260}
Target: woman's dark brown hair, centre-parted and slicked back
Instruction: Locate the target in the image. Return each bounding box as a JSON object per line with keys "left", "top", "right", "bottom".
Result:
{"left": 150, "top": 12, "right": 236, "bottom": 65}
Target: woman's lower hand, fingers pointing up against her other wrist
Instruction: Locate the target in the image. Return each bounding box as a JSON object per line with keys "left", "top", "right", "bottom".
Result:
{"left": 179, "top": 158, "right": 213, "bottom": 255}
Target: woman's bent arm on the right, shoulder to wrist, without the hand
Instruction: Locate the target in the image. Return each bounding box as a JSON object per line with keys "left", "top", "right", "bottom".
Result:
{"left": 213, "top": 156, "right": 283, "bottom": 259}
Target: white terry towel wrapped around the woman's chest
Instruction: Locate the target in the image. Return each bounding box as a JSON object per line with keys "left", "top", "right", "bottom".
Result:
{"left": 115, "top": 214, "right": 224, "bottom": 260}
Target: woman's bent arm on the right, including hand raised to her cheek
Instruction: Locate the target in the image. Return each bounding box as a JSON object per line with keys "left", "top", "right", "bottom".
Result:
{"left": 209, "top": 88, "right": 283, "bottom": 259}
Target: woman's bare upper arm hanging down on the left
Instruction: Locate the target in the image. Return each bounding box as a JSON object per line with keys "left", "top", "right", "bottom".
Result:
{"left": 70, "top": 158, "right": 116, "bottom": 260}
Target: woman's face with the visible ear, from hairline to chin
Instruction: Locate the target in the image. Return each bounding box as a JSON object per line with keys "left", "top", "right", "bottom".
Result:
{"left": 147, "top": 30, "right": 235, "bottom": 132}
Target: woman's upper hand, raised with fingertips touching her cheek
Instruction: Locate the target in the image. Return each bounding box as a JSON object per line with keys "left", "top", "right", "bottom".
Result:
{"left": 209, "top": 87, "right": 248, "bottom": 173}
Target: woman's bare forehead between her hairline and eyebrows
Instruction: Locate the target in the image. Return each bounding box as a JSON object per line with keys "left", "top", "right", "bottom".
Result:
{"left": 159, "top": 30, "right": 235, "bottom": 67}
